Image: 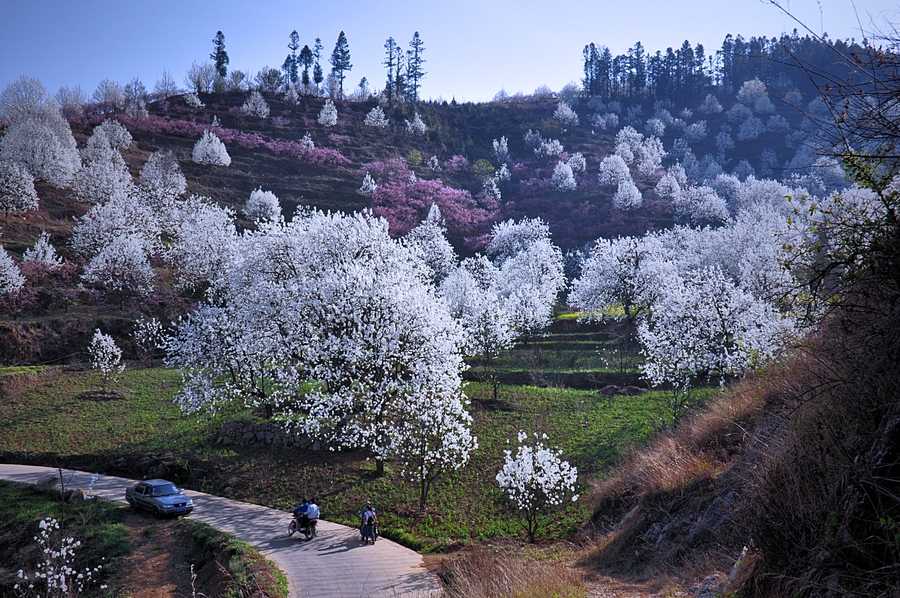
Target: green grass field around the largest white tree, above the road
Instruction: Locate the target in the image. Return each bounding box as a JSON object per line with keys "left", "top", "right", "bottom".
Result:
{"left": 0, "top": 328, "right": 716, "bottom": 551}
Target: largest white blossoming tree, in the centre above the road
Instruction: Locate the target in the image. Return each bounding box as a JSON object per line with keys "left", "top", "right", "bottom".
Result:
{"left": 167, "top": 212, "right": 474, "bottom": 488}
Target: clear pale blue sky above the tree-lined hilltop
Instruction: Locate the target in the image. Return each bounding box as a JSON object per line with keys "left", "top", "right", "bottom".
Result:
{"left": 0, "top": 0, "right": 900, "bottom": 101}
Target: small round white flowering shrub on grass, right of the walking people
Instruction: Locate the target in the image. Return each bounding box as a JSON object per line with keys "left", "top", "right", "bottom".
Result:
{"left": 497, "top": 432, "right": 578, "bottom": 542}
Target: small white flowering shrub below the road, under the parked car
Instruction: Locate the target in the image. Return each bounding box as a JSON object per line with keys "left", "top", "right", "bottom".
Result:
{"left": 13, "top": 517, "right": 106, "bottom": 598}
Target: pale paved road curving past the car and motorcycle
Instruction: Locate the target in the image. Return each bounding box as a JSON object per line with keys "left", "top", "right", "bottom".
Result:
{"left": 0, "top": 464, "right": 438, "bottom": 598}
